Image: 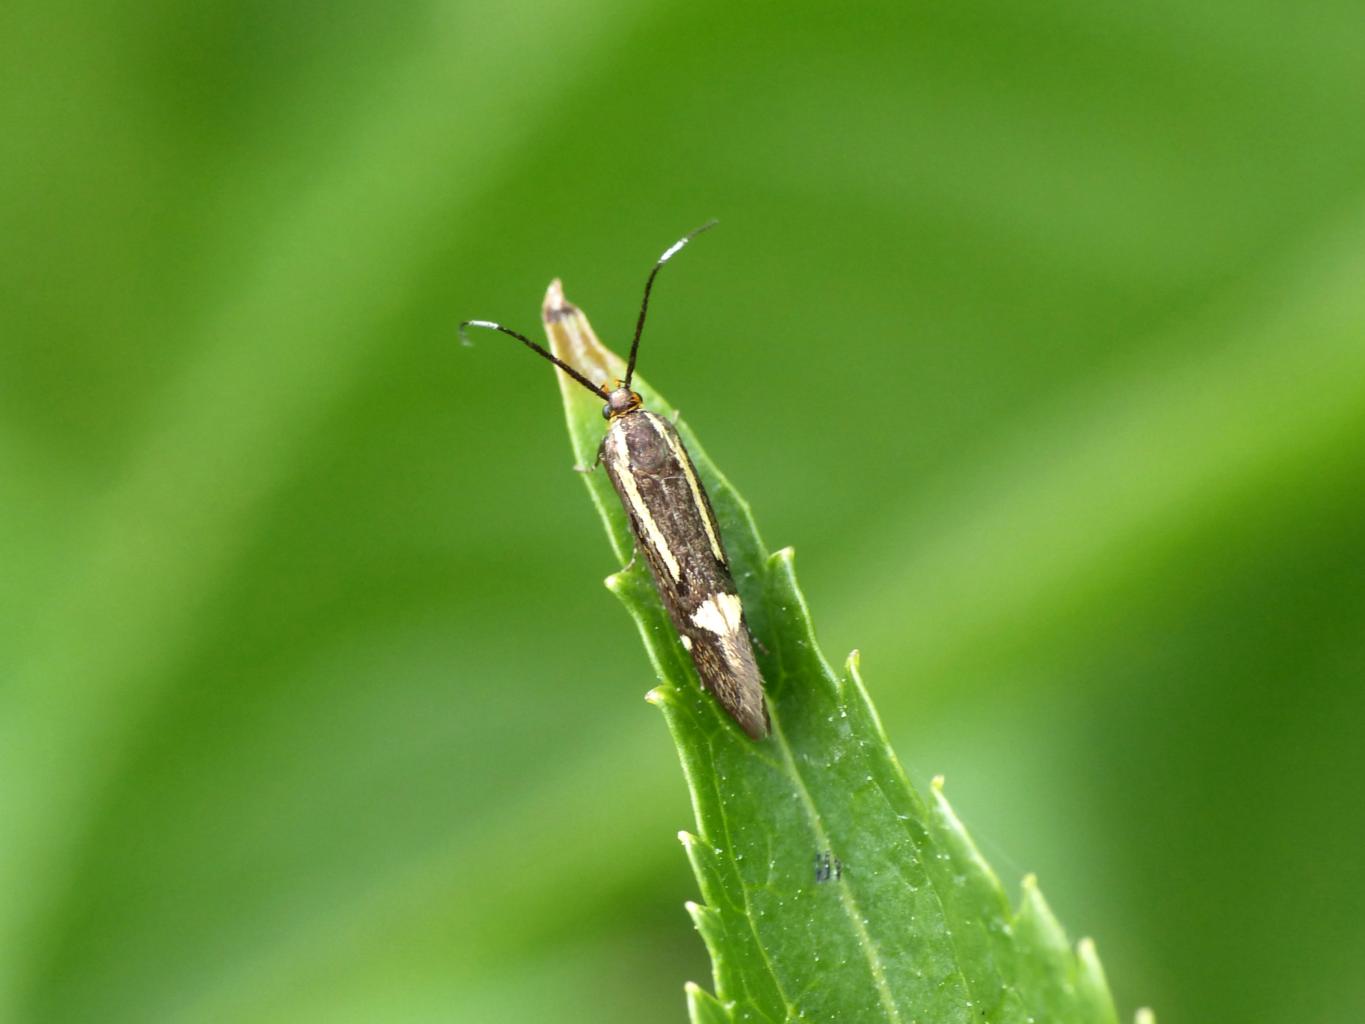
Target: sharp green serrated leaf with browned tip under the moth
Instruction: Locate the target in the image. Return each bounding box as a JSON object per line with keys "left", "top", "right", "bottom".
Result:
{"left": 546, "top": 281, "right": 1117, "bottom": 1024}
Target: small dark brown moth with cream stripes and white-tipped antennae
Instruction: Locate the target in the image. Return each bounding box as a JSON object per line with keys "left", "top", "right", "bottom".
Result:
{"left": 460, "top": 221, "right": 768, "bottom": 740}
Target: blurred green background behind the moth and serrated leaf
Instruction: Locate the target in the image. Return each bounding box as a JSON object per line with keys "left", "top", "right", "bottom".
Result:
{"left": 0, "top": 0, "right": 1365, "bottom": 1024}
